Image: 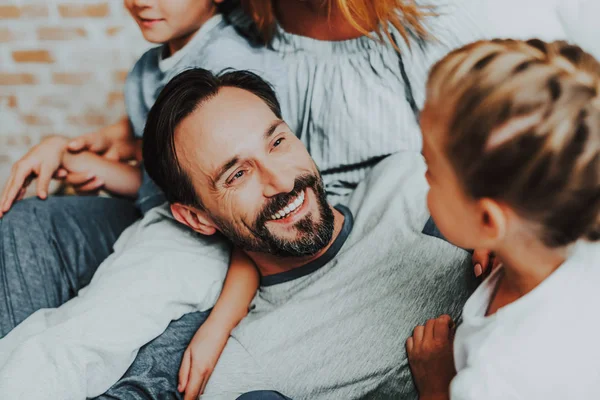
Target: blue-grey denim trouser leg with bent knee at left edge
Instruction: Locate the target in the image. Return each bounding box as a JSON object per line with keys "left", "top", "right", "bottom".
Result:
{"left": 0, "top": 196, "right": 139, "bottom": 336}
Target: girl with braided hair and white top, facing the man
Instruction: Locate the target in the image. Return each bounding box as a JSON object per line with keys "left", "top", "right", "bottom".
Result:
{"left": 406, "top": 40, "right": 600, "bottom": 400}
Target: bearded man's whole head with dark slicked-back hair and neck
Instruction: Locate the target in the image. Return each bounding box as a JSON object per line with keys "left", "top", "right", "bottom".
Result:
{"left": 144, "top": 70, "right": 344, "bottom": 276}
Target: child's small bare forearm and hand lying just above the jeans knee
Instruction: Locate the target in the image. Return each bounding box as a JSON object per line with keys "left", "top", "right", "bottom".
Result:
{"left": 62, "top": 151, "right": 142, "bottom": 197}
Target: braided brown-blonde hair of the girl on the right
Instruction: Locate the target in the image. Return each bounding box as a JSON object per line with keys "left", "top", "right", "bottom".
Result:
{"left": 427, "top": 39, "right": 600, "bottom": 247}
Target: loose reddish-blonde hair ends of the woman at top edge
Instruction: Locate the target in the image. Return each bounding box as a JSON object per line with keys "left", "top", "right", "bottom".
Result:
{"left": 241, "top": 0, "right": 431, "bottom": 44}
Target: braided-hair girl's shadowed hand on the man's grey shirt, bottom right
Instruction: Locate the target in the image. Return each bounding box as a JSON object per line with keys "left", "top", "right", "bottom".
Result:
{"left": 406, "top": 315, "right": 456, "bottom": 400}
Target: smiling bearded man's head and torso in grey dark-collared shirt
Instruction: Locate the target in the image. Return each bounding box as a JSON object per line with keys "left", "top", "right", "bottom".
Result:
{"left": 138, "top": 69, "right": 472, "bottom": 399}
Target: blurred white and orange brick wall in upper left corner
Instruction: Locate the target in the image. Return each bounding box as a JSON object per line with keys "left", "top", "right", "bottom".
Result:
{"left": 0, "top": 0, "right": 150, "bottom": 191}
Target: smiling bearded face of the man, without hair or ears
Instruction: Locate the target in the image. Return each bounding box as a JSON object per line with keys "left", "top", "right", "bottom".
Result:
{"left": 175, "top": 87, "right": 334, "bottom": 257}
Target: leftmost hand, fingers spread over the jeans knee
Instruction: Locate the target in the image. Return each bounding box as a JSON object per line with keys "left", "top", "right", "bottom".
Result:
{"left": 0, "top": 136, "right": 67, "bottom": 217}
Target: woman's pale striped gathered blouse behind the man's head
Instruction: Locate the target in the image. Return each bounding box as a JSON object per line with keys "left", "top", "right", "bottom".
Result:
{"left": 230, "top": 0, "right": 560, "bottom": 204}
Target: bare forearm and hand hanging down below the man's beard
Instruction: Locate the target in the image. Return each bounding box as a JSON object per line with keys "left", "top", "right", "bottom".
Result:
{"left": 177, "top": 248, "right": 259, "bottom": 400}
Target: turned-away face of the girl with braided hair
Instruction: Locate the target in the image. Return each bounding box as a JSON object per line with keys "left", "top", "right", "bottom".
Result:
{"left": 421, "top": 104, "right": 489, "bottom": 249}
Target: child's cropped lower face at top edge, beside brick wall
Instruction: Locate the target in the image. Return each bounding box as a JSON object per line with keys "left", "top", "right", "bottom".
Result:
{"left": 124, "top": 0, "right": 222, "bottom": 47}
